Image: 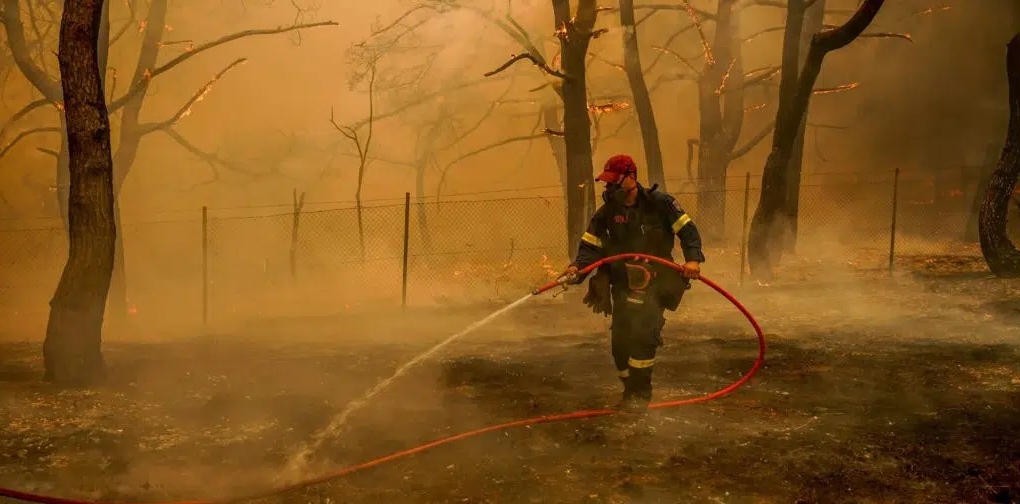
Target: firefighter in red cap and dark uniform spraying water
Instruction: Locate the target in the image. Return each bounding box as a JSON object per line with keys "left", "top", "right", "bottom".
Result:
{"left": 563, "top": 154, "right": 705, "bottom": 411}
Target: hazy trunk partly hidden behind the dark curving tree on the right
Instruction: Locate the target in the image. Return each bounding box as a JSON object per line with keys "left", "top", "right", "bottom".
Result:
{"left": 783, "top": 0, "right": 825, "bottom": 254}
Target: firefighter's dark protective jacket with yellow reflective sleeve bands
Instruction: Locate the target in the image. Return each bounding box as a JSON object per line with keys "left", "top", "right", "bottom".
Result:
{"left": 572, "top": 185, "right": 705, "bottom": 314}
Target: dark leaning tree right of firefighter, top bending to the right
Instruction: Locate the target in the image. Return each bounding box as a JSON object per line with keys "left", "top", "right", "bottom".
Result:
{"left": 748, "top": 0, "right": 884, "bottom": 280}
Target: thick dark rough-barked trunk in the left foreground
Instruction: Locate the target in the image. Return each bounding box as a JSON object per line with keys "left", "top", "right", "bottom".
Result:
{"left": 43, "top": 0, "right": 116, "bottom": 385}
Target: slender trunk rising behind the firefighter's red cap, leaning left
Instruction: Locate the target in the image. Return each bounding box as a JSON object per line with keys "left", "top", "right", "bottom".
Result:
{"left": 620, "top": 0, "right": 666, "bottom": 191}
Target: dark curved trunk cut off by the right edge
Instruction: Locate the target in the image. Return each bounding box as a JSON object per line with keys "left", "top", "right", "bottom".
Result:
{"left": 978, "top": 34, "right": 1020, "bottom": 279}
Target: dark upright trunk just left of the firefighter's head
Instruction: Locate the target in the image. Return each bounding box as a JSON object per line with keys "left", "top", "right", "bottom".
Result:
{"left": 552, "top": 0, "right": 597, "bottom": 256}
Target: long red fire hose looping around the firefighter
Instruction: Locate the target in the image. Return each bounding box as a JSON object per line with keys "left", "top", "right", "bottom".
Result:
{"left": 0, "top": 254, "right": 765, "bottom": 504}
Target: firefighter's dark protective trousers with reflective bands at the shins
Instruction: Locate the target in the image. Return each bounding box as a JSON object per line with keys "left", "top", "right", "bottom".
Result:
{"left": 610, "top": 279, "right": 666, "bottom": 402}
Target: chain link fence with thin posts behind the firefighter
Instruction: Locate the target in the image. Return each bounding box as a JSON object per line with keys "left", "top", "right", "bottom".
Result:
{"left": 0, "top": 167, "right": 1003, "bottom": 334}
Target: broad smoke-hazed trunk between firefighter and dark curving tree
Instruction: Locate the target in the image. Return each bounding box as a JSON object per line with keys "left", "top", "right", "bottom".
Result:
{"left": 697, "top": 0, "right": 744, "bottom": 241}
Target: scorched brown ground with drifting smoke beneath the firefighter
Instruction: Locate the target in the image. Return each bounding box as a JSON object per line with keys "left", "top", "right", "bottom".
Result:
{"left": 0, "top": 257, "right": 1020, "bottom": 504}
